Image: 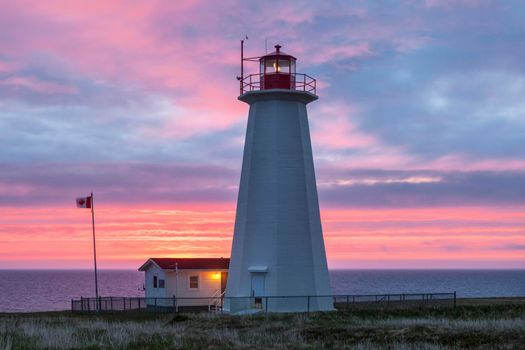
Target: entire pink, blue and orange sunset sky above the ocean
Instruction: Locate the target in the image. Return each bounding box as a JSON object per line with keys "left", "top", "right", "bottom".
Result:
{"left": 0, "top": 0, "right": 525, "bottom": 269}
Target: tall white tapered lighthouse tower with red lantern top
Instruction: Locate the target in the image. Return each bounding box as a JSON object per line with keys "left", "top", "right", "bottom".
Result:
{"left": 224, "top": 45, "right": 333, "bottom": 313}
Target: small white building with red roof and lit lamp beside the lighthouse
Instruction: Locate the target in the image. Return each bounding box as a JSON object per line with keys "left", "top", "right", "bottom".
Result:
{"left": 139, "top": 258, "right": 230, "bottom": 307}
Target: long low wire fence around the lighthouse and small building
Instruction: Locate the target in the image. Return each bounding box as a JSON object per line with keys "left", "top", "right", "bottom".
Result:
{"left": 71, "top": 292, "right": 456, "bottom": 313}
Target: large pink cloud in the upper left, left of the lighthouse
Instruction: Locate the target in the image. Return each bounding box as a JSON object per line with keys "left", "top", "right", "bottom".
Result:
{"left": 0, "top": 1, "right": 243, "bottom": 136}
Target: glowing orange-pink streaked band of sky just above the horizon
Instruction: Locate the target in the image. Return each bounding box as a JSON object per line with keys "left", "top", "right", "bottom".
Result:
{"left": 0, "top": 205, "right": 525, "bottom": 268}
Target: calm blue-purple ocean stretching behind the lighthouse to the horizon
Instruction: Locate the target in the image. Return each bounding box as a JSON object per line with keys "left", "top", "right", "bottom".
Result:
{"left": 0, "top": 270, "right": 525, "bottom": 312}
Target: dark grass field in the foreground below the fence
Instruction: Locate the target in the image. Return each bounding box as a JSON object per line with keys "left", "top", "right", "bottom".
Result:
{"left": 0, "top": 299, "right": 525, "bottom": 350}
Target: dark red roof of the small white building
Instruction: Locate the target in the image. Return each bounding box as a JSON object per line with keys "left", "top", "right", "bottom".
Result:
{"left": 139, "top": 258, "right": 230, "bottom": 271}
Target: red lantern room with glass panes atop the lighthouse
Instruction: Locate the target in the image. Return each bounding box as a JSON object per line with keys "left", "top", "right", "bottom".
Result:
{"left": 259, "top": 45, "right": 296, "bottom": 90}
